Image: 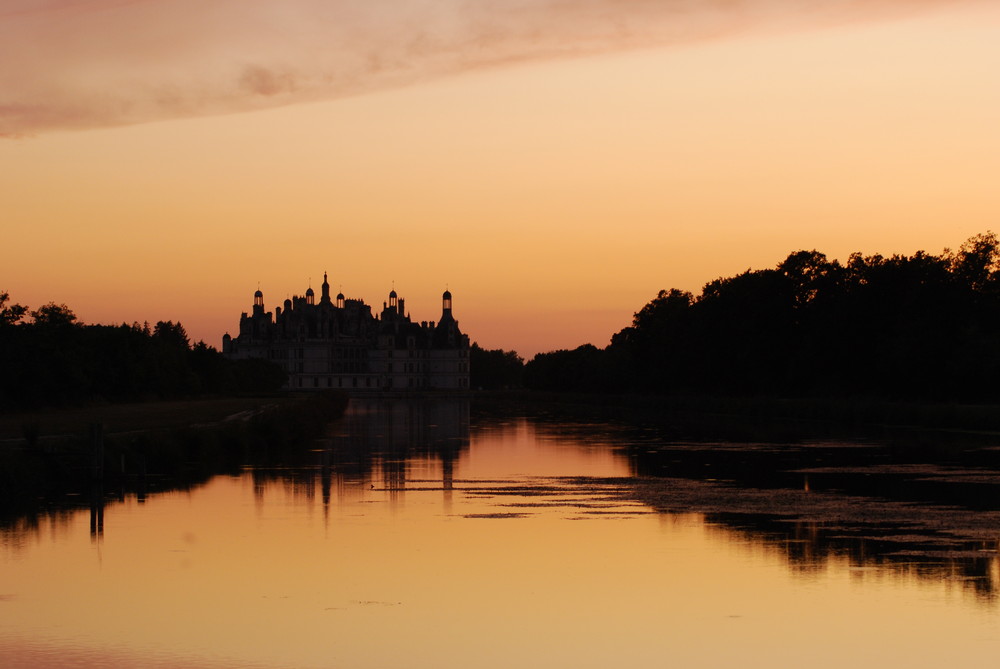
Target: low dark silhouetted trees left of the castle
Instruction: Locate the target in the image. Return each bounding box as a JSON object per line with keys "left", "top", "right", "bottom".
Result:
{"left": 0, "top": 293, "right": 285, "bottom": 408}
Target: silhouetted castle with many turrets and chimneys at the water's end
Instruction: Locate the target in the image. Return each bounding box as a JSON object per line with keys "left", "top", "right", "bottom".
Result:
{"left": 222, "top": 273, "right": 469, "bottom": 395}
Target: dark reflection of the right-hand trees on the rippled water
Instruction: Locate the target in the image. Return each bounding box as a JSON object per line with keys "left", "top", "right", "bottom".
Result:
{"left": 535, "top": 417, "right": 1000, "bottom": 601}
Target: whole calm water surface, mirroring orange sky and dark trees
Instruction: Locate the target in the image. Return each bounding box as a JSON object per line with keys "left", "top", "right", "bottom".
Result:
{"left": 0, "top": 402, "right": 1000, "bottom": 667}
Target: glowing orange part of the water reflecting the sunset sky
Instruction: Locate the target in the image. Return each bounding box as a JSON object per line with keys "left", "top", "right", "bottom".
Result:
{"left": 0, "top": 400, "right": 1000, "bottom": 667}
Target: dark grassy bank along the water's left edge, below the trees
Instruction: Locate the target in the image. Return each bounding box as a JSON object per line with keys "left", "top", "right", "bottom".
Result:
{"left": 0, "top": 392, "right": 347, "bottom": 544}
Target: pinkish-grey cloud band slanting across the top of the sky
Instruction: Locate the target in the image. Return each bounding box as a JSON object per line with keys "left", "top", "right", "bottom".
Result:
{"left": 0, "top": 0, "right": 962, "bottom": 137}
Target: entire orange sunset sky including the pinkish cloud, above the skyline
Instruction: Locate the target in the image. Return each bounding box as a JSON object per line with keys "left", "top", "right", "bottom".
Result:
{"left": 0, "top": 0, "right": 1000, "bottom": 357}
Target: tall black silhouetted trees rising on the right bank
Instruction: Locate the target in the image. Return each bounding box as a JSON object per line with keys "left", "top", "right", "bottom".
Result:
{"left": 524, "top": 232, "right": 1000, "bottom": 400}
